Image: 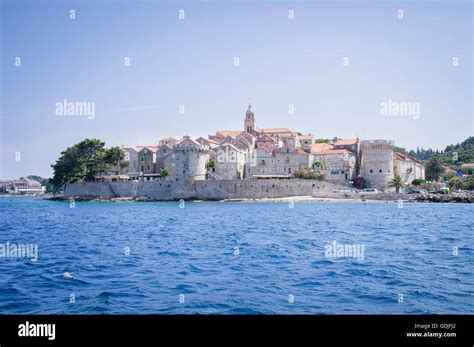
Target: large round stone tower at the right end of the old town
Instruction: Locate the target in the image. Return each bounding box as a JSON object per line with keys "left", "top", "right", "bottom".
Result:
{"left": 360, "top": 140, "right": 394, "bottom": 189}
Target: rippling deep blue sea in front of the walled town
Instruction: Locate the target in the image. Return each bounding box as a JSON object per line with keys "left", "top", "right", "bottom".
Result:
{"left": 0, "top": 198, "right": 474, "bottom": 314}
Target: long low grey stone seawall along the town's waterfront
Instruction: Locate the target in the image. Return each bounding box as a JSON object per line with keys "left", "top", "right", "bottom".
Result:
{"left": 64, "top": 179, "right": 340, "bottom": 200}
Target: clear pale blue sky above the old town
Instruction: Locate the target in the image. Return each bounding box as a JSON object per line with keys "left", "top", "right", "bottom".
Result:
{"left": 0, "top": 0, "right": 474, "bottom": 179}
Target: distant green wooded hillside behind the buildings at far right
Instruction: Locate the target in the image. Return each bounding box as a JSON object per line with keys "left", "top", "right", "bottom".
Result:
{"left": 395, "top": 136, "right": 474, "bottom": 166}
